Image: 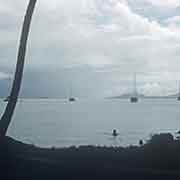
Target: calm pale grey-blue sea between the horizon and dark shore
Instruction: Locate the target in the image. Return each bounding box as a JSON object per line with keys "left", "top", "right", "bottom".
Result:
{"left": 0, "top": 99, "right": 180, "bottom": 147}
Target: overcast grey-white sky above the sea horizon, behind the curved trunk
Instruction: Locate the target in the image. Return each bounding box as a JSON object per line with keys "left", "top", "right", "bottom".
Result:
{"left": 0, "top": 0, "right": 180, "bottom": 97}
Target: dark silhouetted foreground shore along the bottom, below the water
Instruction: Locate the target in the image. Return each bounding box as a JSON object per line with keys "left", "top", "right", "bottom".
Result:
{"left": 0, "top": 134, "right": 180, "bottom": 180}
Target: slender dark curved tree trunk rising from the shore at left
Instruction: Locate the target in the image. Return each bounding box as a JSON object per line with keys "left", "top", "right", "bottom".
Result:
{"left": 0, "top": 0, "right": 36, "bottom": 138}
